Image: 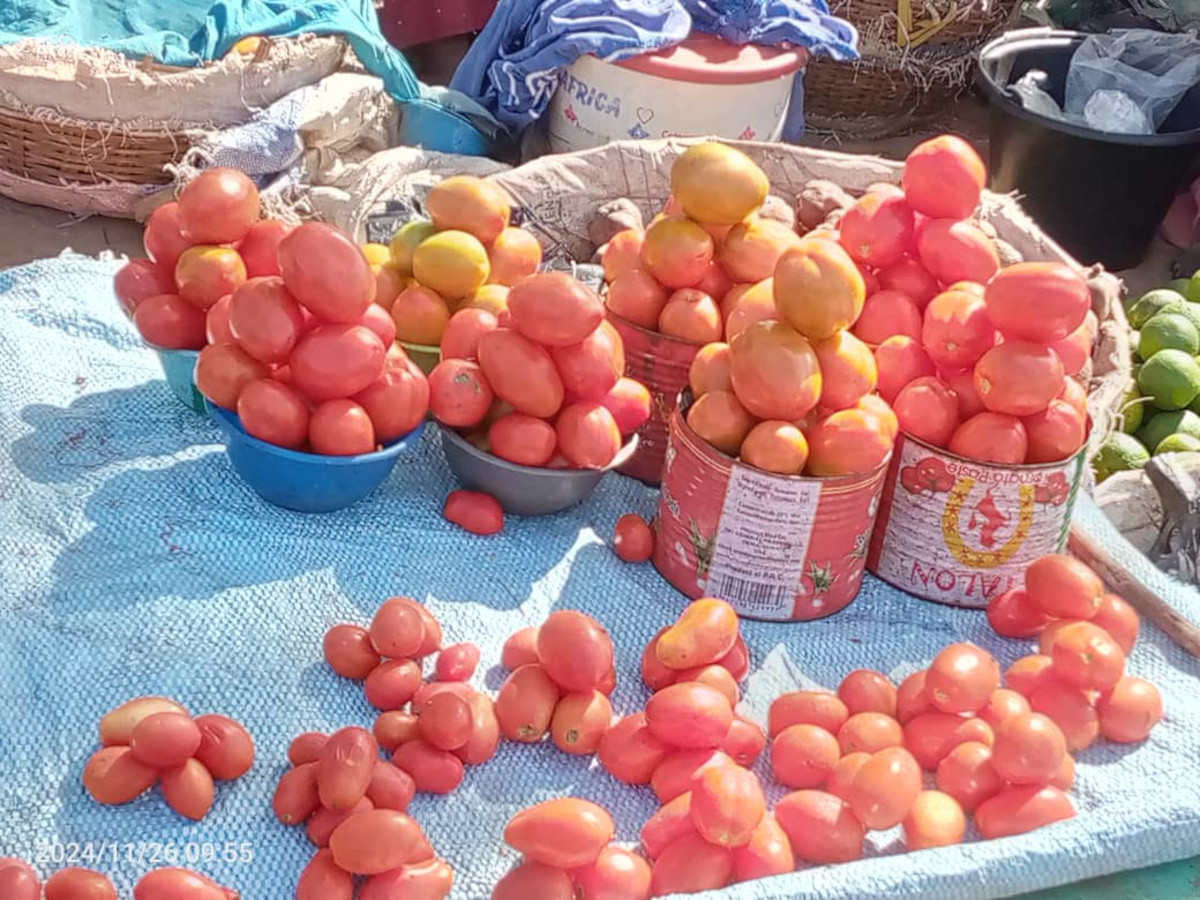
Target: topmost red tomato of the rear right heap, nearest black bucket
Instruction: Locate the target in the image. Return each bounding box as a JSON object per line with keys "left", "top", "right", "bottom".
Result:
{"left": 900, "top": 134, "right": 988, "bottom": 220}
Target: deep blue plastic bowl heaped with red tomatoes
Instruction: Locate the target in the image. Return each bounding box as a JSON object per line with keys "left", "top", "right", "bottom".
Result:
{"left": 208, "top": 403, "right": 425, "bottom": 512}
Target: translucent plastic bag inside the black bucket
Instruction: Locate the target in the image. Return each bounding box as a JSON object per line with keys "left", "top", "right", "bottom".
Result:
{"left": 1063, "top": 29, "right": 1200, "bottom": 134}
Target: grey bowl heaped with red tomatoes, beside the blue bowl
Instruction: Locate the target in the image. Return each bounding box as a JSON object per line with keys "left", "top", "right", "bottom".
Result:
{"left": 440, "top": 426, "right": 637, "bottom": 516}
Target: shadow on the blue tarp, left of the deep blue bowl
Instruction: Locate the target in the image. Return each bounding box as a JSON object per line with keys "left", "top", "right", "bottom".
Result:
{"left": 11, "top": 379, "right": 218, "bottom": 484}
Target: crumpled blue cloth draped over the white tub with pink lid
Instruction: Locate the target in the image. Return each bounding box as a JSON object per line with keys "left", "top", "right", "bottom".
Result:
{"left": 450, "top": 0, "right": 858, "bottom": 140}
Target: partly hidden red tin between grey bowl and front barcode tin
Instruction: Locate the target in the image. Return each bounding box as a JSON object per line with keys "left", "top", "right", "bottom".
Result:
{"left": 608, "top": 312, "right": 701, "bottom": 485}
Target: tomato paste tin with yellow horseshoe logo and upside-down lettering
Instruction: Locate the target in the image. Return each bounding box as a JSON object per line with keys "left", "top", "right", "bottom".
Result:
{"left": 866, "top": 434, "right": 1087, "bottom": 608}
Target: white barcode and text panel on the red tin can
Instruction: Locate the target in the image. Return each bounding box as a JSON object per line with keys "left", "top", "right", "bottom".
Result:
{"left": 704, "top": 464, "right": 821, "bottom": 619}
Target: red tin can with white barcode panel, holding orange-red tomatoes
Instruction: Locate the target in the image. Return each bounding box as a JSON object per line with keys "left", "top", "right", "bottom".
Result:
{"left": 654, "top": 395, "right": 888, "bottom": 622}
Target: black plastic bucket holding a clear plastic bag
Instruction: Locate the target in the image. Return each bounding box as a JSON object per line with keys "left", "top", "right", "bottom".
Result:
{"left": 977, "top": 28, "right": 1200, "bottom": 270}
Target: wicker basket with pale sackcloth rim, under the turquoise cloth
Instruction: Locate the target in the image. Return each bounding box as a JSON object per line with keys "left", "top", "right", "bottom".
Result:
{"left": 0, "top": 36, "right": 344, "bottom": 217}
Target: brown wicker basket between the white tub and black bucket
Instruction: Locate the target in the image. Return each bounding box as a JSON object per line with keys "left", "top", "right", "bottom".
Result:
{"left": 804, "top": 0, "right": 1018, "bottom": 138}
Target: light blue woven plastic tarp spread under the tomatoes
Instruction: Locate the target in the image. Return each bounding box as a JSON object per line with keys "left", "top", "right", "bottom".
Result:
{"left": 0, "top": 250, "right": 1200, "bottom": 900}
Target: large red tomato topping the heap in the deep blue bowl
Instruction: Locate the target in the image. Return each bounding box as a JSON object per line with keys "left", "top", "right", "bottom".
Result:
{"left": 278, "top": 222, "right": 374, "bottom": 324}
